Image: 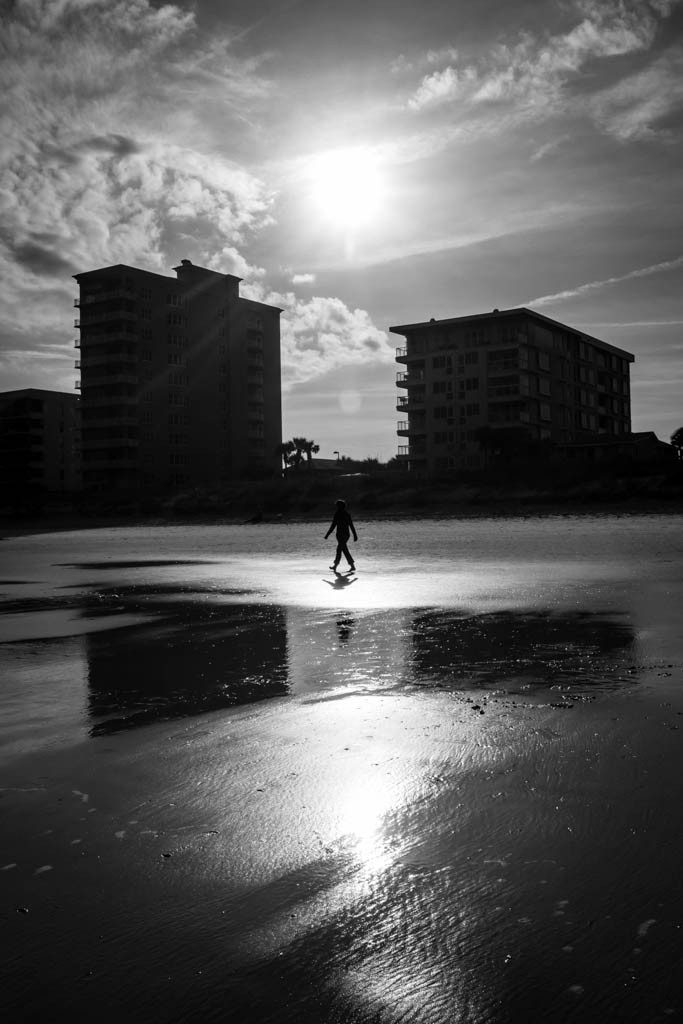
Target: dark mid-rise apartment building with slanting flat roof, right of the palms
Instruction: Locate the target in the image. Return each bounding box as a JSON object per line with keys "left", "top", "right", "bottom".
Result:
{"left": 390, "top": 307, "right": 634, "bottom": 473}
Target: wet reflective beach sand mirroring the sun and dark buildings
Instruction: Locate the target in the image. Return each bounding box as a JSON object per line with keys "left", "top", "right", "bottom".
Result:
{"left": 0, "top": 519, "right": 683, "bottom": 1024}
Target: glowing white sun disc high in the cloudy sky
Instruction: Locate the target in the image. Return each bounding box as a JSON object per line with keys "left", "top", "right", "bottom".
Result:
{"left": 309, "top": 148, "right": 383, "bottom": 229}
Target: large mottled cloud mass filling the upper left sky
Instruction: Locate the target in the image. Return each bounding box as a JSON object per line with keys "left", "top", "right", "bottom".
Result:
{"left": 0, "top": 0, "right": 271, "bottom": 311}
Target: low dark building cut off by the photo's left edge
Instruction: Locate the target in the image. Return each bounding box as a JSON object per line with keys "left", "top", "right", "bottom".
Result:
{"left": 0, "top": 387, "right": 81, "bottom": 497}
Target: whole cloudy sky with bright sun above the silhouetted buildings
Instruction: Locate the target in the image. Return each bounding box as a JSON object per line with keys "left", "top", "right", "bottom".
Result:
{"left": 0, "top": 0, "right": 683, "bottom": 459}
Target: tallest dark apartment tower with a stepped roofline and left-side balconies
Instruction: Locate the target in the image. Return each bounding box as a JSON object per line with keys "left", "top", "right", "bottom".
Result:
{"left": 75, "top": 259, "right": 282, "bottom": 490}
